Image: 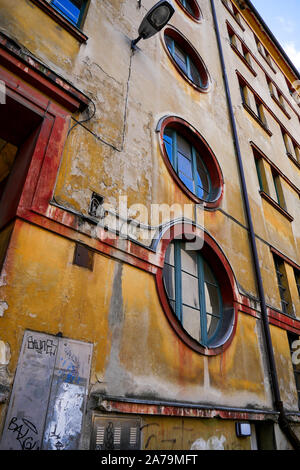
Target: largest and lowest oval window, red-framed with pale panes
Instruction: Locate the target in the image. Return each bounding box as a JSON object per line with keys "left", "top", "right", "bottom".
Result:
{"left": 157, "top": 224, "right": 238, "bottom": 355}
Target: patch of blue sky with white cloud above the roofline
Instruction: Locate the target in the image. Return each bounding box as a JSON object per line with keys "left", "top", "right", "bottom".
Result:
{"left": 251, "top": 0, "right": 300, "bottom": 71}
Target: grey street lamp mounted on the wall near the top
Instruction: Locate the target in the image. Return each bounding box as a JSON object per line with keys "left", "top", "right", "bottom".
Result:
{"left": 131, "top": 0, "right": 175, "bottom": 49}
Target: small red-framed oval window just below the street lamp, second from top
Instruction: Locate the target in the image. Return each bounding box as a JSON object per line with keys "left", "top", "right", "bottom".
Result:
{"left": 164, "top": 27, "right": 210, "bottom": 91}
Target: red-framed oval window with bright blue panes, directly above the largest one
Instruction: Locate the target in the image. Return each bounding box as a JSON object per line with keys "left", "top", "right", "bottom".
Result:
{"left": 160, "top": 117, "right": 223, "bottom": 208}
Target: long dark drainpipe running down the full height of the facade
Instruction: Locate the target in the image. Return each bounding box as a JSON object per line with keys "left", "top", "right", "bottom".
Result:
{"left": 211, "top": 0, "right": 300, "bottom": 450}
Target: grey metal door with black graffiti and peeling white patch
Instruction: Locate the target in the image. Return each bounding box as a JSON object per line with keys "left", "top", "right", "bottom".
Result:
{"left": 0, "top": 331, "right": 92, "bottom": 450}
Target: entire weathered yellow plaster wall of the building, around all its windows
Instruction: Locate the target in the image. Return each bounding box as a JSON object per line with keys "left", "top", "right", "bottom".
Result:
{"left": 0, "top": 0, "right": 300, "bottom": 449}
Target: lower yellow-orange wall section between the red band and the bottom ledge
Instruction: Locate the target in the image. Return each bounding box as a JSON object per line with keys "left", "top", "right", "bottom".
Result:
{"left": 0, "top": 222, "right": 271, "bottom": 407}
